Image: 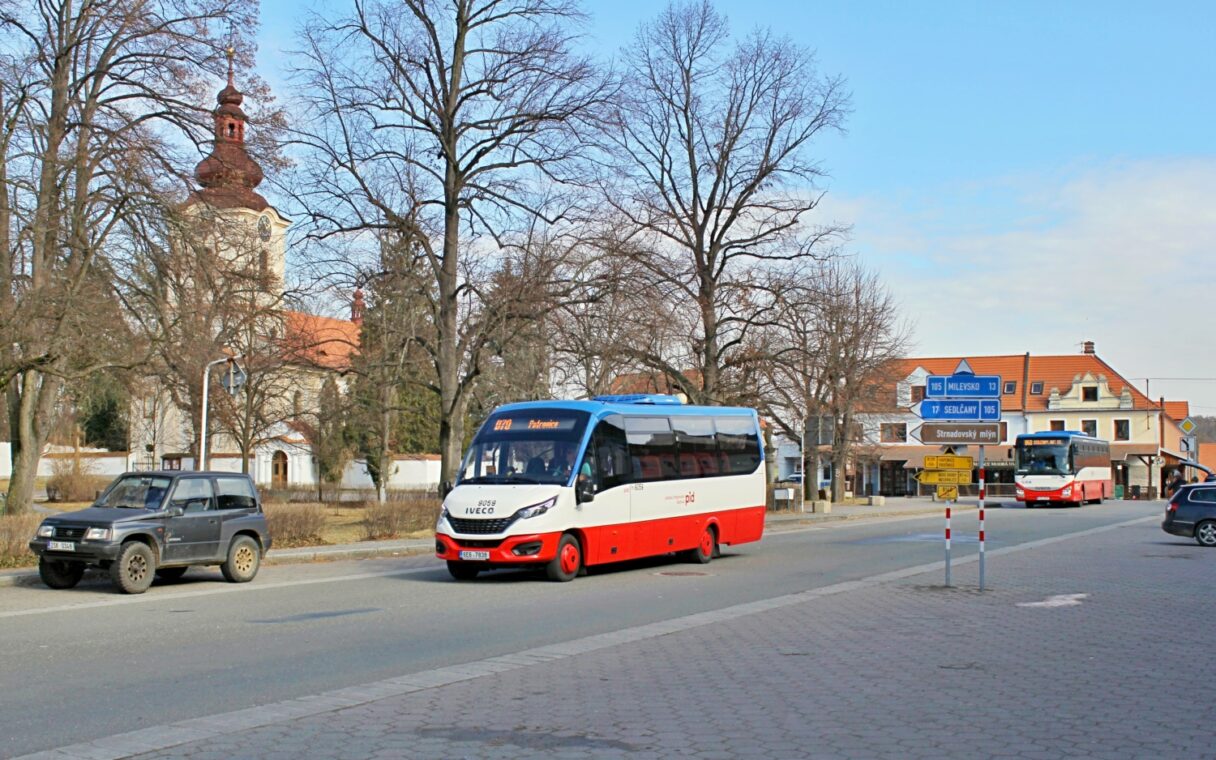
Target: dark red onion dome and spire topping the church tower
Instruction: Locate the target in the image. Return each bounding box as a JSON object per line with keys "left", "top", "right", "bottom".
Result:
{"left": 191, "top": 51, "right": 270, "bottom": 212}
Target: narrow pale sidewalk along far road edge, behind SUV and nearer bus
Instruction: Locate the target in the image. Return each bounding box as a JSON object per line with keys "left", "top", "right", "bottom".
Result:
{"left": 0, "top": 497, "right": 967, "bottom": 587}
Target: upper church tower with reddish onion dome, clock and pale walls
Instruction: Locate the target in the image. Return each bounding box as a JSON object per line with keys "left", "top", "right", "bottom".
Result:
{"left": 187, "top": 49, "right": 291, "bottom": 299}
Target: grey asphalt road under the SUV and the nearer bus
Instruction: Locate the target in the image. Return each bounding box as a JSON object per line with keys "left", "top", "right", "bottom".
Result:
{"left": 0, "top": 502, "right": 1183, "bottom": 756}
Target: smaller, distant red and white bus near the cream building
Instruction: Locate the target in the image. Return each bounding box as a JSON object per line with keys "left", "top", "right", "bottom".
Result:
{"left": 1013, "top": 430, "right": 1114, "bottom": 507}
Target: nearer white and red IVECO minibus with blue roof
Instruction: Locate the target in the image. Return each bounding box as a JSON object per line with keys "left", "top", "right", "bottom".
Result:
{"left": 435, "top": 394, "right": 766, "bottom": 581}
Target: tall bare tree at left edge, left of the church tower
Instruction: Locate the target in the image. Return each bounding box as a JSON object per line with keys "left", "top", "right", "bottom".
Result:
{"left": 0, "top": 0, "right": 257, "bottom": 512}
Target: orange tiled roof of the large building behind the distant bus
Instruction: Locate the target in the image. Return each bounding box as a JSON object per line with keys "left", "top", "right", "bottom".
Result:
{"left": 884, "top": 354, "right": 1158, "bottom": 412}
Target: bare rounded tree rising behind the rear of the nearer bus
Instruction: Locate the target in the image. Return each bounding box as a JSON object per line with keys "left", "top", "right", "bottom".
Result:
{"left": 603, "top": 0, "right": 846, "bottom": 402}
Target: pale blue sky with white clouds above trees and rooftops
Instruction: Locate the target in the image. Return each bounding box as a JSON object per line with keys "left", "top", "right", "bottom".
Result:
{"left": 259, "top": 0, "right": 1216, "bottom": 415}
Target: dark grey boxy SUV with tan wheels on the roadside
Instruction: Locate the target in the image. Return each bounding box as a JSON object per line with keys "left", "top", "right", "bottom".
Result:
{"left": 29, "top": 471, "right": 270, "bottom": 593}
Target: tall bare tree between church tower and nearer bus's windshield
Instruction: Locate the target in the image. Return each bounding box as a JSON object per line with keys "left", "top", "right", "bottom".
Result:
{"left": 290, "top": 0, "right": 607, "bottom": 478}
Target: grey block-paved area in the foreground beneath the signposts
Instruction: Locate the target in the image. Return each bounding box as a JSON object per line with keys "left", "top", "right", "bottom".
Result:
{"left": 23, "top": 520, "right": 1216, "bottom": 760}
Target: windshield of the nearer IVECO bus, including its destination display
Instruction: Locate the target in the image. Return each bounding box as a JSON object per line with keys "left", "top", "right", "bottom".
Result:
{"left": 457, "top": 409, "right": 589, "bottom": 484}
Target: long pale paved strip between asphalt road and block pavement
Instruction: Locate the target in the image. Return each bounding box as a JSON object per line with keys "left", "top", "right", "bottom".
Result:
{"left": 16, "top": 516, "right": 1160, "bottom": 760}
